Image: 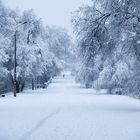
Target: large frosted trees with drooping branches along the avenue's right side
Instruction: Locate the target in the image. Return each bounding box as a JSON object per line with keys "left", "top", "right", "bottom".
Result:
{"left": 72, "top": 0, "right": 140, "bottom": 96}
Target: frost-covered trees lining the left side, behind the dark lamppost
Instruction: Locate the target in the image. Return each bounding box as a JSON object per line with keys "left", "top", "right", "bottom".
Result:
{"left": 0, "top": 1, "right": 71, "bottom": 92}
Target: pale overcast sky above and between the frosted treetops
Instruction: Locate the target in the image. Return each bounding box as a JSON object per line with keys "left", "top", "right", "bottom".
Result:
{"left": 3, "top": 0, "right": 90, "bottom": 31}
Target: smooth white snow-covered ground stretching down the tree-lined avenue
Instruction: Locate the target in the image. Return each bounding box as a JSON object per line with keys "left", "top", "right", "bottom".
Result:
{"left": 0, "top": 75, "right": 140, "bottom": 140}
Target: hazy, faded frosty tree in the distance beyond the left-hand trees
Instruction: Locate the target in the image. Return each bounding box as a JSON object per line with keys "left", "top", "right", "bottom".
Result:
{"left": 47, "top": 27, "right": 72, "bottom": 68}
